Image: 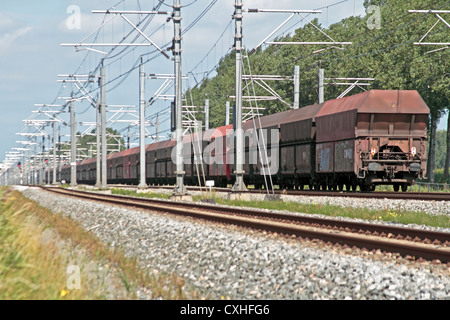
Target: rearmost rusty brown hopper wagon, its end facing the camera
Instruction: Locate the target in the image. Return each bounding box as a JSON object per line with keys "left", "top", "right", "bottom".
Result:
{"left": 315, "top": 90, "right": 430, "bottom": 191}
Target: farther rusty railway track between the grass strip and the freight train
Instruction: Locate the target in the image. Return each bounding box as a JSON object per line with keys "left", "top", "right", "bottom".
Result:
{"left": 110, "top": 185, "right": 450, "bottom": 201}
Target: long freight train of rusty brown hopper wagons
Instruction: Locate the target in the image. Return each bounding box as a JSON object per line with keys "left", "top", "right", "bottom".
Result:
{"left": 56, "top": 90, "right": 430, "bottom": 191}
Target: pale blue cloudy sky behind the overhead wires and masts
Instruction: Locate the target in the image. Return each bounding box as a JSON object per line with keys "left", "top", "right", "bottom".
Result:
{"left": 0, "top": 0, "right": 446, "bottom": 168}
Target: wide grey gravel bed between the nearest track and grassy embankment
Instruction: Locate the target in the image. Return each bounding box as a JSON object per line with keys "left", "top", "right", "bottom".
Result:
{"left": 15, "top": 188, "right": 450, "bottom": 300}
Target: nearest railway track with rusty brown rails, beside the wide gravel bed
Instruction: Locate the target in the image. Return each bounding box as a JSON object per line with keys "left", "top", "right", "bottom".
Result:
{"left": 41, "top": 187, "right": 450, "bottom": 263}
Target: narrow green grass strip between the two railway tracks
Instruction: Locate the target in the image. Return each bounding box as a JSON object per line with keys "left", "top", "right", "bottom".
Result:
{"left": 112, "top": 189, "right": 450, "bottom": 228}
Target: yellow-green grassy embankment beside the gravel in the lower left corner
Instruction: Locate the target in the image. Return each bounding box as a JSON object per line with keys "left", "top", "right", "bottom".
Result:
{"left": 0, "top": 188, "right": 200, "bottom": 300}
